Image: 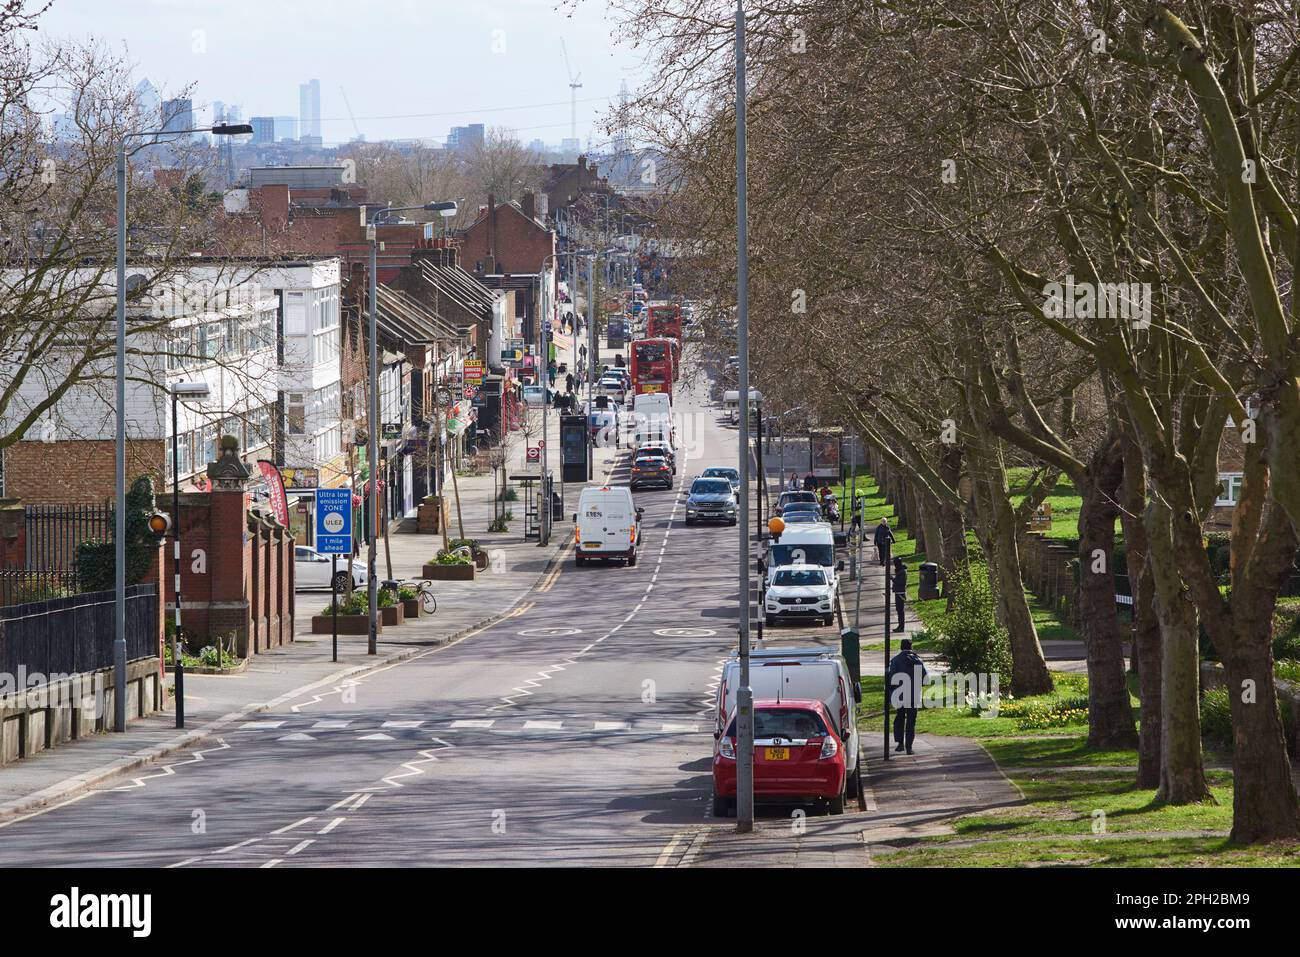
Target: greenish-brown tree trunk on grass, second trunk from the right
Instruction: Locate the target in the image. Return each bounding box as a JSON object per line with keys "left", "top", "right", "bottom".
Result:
{"left": 1147, "top": 498, "right": 1213, "bottom": 804}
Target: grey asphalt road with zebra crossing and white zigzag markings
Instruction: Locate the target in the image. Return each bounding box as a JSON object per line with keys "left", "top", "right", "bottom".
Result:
{"left": 0, "top": 351, "right": 863, "bottom": 867}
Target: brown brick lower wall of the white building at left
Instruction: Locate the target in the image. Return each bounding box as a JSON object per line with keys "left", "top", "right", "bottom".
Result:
{"left": 4, "top": 439, "right": 165, "bottom": 505}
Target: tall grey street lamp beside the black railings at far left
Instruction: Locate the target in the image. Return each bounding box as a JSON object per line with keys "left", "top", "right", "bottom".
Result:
{"left": 113, "top": 124, "right": 252, "bottom": 731}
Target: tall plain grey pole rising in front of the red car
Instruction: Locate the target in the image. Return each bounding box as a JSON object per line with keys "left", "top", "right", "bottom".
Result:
{"left": 736, "top": 0, "right": 754, "bottom": 833}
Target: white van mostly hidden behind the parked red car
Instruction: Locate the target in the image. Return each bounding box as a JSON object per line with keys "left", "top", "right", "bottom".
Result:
{"left": 714, "top": 648, "right": 862, "bottom": 797}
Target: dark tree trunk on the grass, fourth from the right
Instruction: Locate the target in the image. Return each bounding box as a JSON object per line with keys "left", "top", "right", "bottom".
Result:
{"left": 1078, "top": 434, "right": 1138, "bottom": 748}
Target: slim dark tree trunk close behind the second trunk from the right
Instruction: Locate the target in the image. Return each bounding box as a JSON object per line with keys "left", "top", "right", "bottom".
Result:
{"left": 1119, "top": 437, "right": 1162, "bottom": 788}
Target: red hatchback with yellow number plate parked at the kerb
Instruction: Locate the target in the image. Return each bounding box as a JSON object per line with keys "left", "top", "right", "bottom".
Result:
{"left": 714, "top": 700, "right": 845, "bottom": 818}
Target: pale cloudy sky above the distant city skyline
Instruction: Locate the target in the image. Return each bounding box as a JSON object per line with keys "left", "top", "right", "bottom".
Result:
{"left": 40, "top": 0, "right": 644, "bottom": 147}
